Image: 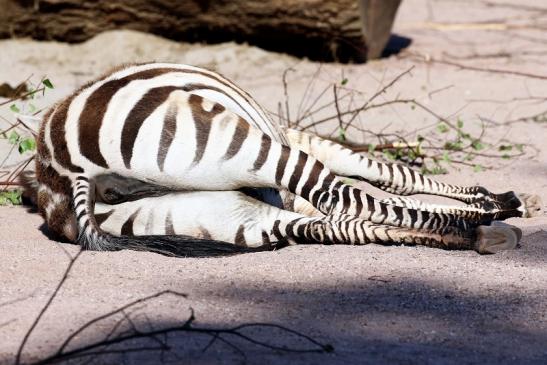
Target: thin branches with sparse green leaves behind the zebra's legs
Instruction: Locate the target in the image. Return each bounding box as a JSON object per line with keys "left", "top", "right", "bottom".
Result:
{"left": 277, "top": 63, "right": 525, "bottom": 174}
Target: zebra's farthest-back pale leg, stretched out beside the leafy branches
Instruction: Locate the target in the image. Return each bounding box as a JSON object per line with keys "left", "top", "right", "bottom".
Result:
{"left": 285, "top": 129, "right": 543, "bottom": 217}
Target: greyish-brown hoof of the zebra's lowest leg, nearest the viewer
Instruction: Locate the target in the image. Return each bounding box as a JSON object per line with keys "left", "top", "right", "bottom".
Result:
{"left": 475, "top": 226, "right": 522, "bottom": 254}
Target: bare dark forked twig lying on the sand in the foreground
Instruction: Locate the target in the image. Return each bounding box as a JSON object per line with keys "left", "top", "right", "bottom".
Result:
{"left": 14, "top": 246, "right": 333, "bottom": 365}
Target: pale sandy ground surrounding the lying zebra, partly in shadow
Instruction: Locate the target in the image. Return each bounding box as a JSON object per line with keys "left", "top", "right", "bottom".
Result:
{"left": 0, "top": 0, "right": 547, "bottom": 364}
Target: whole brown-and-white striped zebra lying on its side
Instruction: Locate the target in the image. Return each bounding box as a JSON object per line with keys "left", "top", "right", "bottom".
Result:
{"left": 19, "top": 63, "right": 542, "bottom": 256}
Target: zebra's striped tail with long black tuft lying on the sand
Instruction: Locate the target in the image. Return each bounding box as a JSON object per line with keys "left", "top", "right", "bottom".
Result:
{"left": 72, "top": 176, "right": 275, "bottom": 257}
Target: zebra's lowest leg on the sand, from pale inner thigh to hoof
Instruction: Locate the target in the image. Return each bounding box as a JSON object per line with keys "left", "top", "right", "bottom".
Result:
{"left": 95, "top": 191, "right": 516, "bottom": 253}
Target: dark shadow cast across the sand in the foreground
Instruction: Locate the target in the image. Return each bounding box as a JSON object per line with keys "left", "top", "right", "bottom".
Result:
{"left": 5, "top": 276, "right": 547, "bottom": 364}
